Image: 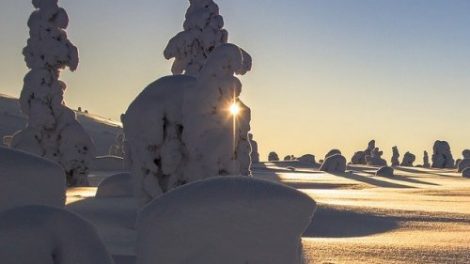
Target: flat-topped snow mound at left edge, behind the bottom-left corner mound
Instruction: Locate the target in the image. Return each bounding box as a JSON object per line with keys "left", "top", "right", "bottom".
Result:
{"left": 0, "top": 147, "right": 65, "bottom": 212}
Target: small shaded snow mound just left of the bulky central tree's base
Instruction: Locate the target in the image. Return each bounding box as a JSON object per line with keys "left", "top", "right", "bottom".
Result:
{"left": 96, "top": 173, "right": 134, "bottom": 198}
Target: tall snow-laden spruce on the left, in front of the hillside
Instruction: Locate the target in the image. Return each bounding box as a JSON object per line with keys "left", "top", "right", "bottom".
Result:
{"left": 11, "top": 0, "right": 95, "bottom": 186}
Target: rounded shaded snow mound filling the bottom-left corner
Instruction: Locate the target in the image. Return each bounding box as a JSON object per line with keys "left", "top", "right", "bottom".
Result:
{"left": 0, "top": 206, "right": 113, "bottom": 264}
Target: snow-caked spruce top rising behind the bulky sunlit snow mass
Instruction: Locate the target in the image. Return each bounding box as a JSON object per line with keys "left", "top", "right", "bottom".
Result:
{"left": 164, "top": 0, "right": 228, "bottom": 77}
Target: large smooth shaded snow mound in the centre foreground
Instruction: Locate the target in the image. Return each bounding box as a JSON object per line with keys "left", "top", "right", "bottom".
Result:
{"left": 136, "top": 177, "right": 316, "bottom": 264}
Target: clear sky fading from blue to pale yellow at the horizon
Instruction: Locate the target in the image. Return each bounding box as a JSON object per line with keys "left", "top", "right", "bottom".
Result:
{"left": 0, "top": 0, "right": 470, "bottom": 163}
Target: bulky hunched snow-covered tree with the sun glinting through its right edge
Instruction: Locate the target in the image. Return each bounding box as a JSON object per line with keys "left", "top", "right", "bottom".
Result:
{"left": 123, "top": 44, "right": 251, "bottom": 203}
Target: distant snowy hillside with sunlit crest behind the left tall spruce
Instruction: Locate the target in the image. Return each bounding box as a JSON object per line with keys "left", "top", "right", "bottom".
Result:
{"left": 0, "top": 94, "right": 122, "bottom": 156}
